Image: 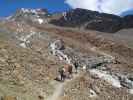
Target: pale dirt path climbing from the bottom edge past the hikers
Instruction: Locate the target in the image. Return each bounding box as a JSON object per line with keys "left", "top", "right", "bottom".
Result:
{"left": 46, "top": 72, "right": 81, "bottom": 100}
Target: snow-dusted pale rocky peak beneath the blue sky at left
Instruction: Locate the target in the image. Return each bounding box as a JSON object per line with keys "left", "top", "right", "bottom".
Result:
{"left": 9, "top": 8, "right": 50, "bottom": 24}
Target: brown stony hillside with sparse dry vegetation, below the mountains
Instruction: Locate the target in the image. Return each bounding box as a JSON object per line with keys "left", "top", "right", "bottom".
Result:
{"left": 0, "top": 8, "right": 133, "bottom": 100}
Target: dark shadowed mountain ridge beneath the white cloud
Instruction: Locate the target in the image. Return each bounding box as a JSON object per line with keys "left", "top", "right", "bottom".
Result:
{"left": 51, "top": 8, "right": 133, "bottom": 33}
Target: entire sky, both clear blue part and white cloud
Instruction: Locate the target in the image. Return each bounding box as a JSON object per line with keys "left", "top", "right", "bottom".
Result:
{"left": 0, "top": 0, "right": 133, "bottom": 16}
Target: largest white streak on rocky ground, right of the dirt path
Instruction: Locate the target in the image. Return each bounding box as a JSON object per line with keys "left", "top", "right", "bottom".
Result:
{"left": 90, "top": 69, "right": 122, "bottom": 88}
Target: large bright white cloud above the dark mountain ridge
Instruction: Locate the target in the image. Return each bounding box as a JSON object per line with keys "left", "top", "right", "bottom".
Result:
{"left": 65, "top": 0, "right": 133, "bottom": 14}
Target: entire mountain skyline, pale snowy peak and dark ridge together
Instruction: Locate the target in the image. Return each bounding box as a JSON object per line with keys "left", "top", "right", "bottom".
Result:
{"left": 5, "top": 8, "right": 133, "bottom": 33}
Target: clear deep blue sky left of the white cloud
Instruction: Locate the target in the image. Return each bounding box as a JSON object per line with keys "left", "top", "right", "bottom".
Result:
{"left": 0, "top": 0, "right": 69, "bottom": 16}
